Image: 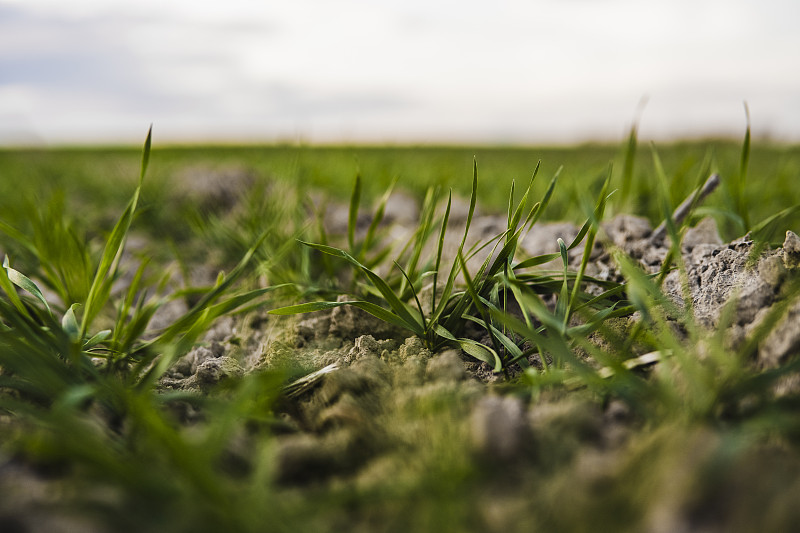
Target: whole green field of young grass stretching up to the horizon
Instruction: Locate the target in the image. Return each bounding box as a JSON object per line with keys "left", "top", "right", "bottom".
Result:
{"left": 0, "top": 135, "right": 800, "bottom": 532}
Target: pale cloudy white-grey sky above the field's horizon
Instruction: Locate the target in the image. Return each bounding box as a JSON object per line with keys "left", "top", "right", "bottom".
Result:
{"left": 0, "top": 0, "right": 800, "bottom": 145}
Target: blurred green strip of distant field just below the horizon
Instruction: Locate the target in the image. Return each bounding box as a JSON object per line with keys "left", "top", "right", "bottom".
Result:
{"left": 0, "top": 140, "right": 800, "bottom": 244}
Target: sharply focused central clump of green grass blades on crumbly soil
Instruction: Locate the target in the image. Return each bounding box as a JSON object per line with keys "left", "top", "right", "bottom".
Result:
{"left": 270, "top": 162, "right": 620, "bottom": 372}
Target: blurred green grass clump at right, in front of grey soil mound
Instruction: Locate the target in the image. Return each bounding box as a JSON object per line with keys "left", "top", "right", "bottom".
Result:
{"left": 510, "top": 144, "right": 800, "bottom": 440}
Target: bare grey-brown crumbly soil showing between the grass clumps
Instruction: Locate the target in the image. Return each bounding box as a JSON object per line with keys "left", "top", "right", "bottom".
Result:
{"left": 0, "top": 184, "right": 800, "bottom": 531}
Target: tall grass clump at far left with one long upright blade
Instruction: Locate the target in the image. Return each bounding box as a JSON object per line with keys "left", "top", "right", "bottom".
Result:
{"left": 0, "top": 127, "right": 281, "bottom": 402}
